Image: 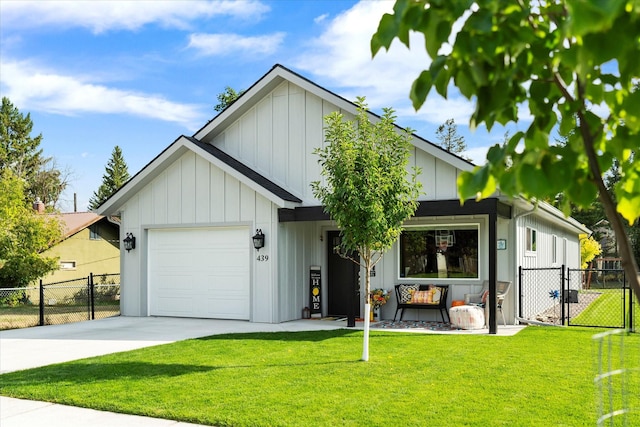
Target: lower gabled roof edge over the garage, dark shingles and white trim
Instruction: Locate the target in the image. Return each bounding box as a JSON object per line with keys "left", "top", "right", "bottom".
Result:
{"left": 96, "top": 135, "right": 302, "bottom": 215}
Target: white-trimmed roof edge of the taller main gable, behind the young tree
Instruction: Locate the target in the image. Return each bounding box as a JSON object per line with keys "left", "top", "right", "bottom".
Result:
{"left": 193, "top": 64, "right": 474, "bottom": 170}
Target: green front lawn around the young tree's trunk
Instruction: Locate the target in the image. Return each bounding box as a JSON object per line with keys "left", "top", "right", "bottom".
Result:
{"left": 0, "top": 327, "right": 640, "bottom": 426}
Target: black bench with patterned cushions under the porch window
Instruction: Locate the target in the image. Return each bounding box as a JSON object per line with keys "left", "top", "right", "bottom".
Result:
{"left": 393, "top": 284, "right": 450, "bottom": 323}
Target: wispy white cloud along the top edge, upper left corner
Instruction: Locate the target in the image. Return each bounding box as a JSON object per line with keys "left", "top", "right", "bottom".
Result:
{"left": 2, "top": 0, "right": 269, "bottom": 33}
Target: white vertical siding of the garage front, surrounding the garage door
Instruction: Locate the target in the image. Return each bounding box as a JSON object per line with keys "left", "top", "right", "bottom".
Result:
{"left": 120, "top": 152, "right": 278, "bottom": 322}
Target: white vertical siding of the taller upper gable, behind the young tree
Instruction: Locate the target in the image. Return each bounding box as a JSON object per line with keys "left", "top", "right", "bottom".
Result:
{"left": 211, "top": 81, "right": 460, "bottom": 206}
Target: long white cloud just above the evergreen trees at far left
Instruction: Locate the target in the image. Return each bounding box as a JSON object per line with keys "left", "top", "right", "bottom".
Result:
{"left": 0, "top": 62, "right": 204, "bottom": 130}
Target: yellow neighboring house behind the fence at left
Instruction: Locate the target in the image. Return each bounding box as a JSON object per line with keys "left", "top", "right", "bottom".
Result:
{"left": 42, "top": 212, "right": 120, "bottom": 283}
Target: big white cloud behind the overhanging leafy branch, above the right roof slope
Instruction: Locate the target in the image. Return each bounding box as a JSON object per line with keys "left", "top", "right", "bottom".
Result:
{"left": 293, "top": 1, "right": 528, "bottom": 144}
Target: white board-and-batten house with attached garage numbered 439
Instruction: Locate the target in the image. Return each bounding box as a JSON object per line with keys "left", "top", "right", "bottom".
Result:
{"left": 98, "top": 65, "right": 588, "bottom": 329}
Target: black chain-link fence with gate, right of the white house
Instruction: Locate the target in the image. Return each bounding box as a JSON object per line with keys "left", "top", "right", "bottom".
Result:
{"left": 518, "top": 266, "right": 640, "bottom": 331}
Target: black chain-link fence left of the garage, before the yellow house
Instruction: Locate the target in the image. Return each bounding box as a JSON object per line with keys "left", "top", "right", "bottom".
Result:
{"left": 0, "top": 273, "right": 120, "bottom": 329}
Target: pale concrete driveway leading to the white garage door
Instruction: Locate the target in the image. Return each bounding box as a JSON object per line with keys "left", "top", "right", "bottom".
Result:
{"left": 0, "top": 316, "right": 346, "bottom": 374}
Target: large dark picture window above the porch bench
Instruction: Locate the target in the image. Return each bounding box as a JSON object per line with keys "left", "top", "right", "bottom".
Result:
{"left": 400, "top": 224, "right": 479, "bottom": 279}
